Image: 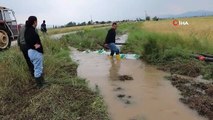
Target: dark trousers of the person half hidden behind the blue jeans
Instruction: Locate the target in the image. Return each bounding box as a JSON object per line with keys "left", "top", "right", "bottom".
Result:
{"left": 20, "top": 45, "right": 34, "bottom": 75}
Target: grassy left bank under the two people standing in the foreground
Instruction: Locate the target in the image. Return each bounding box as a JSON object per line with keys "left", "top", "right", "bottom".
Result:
{"left": 0, "top": 37, "right": 109, "bottom": 120}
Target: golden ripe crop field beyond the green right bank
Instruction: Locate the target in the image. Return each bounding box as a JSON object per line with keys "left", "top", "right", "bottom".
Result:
{"left": 141, "top": 17, "right": 213, "bottom": 42}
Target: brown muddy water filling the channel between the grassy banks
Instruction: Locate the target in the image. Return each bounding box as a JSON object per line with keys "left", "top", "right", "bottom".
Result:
{"left": 72, "top": 50, "right": 205, "bottom": 120}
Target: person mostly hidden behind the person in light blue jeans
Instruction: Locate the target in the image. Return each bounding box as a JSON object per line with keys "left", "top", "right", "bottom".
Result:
{"left": 18, "top": 21, "right": 34, "bottom": 76}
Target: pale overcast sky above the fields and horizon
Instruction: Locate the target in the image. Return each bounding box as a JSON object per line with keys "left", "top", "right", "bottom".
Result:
{"left": 0, "top": 0, "right": 213, "bottom": 25}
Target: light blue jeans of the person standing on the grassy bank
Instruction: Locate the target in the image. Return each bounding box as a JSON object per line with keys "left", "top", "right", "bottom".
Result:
{"left": 28, "top": 49, "right": 43, "bottom": 78}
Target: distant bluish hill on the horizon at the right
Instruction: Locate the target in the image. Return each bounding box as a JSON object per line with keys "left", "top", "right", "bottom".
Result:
{"left": 159, "top": 10, "right": 213, "bottom": 18}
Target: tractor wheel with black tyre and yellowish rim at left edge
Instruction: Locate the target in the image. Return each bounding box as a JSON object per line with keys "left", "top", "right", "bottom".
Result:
{"left": 0, "top": 27, "right": 11, "bottom": 50}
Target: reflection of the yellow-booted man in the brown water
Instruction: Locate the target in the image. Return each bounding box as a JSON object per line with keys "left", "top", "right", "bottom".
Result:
{"left": 109, "top": 59, "right": 121, "bottom": 81}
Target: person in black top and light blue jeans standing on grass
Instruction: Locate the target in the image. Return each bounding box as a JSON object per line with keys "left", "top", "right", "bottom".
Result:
{"left": 24, "top": 16, "right": 44, "bottom": 88}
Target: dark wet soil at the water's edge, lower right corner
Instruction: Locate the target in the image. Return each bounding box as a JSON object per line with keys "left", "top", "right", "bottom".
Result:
{"left": 169, "top": 75, "right": 213, "bottom": 120}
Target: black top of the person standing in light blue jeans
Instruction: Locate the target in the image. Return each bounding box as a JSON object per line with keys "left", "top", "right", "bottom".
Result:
{"left": 24, "top": 26, "right": 43, "bottom": 53}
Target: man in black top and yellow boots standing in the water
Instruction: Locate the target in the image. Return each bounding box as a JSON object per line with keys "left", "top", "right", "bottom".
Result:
{"left": 104, "top": 22, "right": 121, "bottom": 60}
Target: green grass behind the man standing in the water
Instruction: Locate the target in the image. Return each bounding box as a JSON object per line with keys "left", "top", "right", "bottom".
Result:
{"left": 61, "top": 23, "right": 133, "bottom": 51}
